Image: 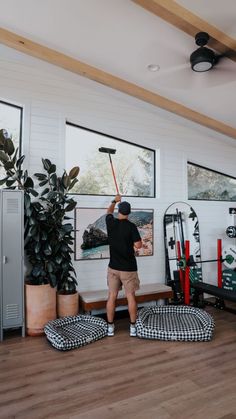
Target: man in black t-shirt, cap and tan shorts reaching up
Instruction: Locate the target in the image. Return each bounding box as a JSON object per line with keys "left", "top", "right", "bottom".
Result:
{"left": 106, "top": 195, "right": 142, "bottom": 336}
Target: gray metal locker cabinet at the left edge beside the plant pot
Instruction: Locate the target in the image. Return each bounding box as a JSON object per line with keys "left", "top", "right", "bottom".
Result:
{"left": 0, "top": 189, "right": 25, "bottom": 341}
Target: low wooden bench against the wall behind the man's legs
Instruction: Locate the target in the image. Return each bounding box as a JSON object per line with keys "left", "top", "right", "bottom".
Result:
{"left": 79, "top": 283, "right": 173, "bottom": 312}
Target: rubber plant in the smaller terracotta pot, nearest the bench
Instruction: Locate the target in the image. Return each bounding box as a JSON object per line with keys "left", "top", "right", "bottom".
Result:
{"left": 35, "top": 159, "right": 79, "bottom": 317}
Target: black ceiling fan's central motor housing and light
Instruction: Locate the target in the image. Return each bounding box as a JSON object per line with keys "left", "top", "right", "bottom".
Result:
{"left": 190, "top": 32, "right": 223, "bottom": 73}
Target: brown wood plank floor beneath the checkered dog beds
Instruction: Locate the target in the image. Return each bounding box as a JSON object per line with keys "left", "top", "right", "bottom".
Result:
{"left": 0, "top": 307, "right": 236, "bottom": 419}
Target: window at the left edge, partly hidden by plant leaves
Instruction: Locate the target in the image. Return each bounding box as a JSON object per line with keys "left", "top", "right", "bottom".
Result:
{"left": 0, "top": 100, "right": 23, "bottom": 178}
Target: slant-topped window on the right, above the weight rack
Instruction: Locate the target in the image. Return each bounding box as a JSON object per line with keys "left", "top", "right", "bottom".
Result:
{"left": 188, "top": 162, "right": 236, "bottom": 201}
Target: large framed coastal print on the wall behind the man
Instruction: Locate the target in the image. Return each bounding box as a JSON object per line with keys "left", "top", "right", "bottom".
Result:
{"left": 75, "top": 208, "right": 154, "bottom": 260}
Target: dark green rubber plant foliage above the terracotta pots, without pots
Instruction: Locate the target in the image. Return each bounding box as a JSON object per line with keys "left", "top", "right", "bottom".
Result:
{"left": 0, "top": 129, "right": 79, "bottom": 293}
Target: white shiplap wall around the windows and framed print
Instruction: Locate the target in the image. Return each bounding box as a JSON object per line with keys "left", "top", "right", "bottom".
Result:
{"left": 0, "top": 46, "right": 236, "bottom": 290}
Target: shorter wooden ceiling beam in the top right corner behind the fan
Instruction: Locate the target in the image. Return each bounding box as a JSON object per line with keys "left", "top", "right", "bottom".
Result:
{"left": 132, "top": 0, "right": 236, "bottom": 61}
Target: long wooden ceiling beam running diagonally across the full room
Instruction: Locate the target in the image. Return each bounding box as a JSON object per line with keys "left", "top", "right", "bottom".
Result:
{"left": 0, "top": 28, "right": 236, "bottom": 139}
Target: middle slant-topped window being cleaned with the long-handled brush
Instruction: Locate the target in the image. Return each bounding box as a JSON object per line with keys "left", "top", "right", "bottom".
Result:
{"left": 65, "top": 123, "right": 155, "bottom": 197}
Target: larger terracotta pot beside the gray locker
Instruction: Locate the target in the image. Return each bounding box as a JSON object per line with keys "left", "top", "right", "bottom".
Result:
{"left": 25, "top": 284, "right": 57, "bottom": 336}
